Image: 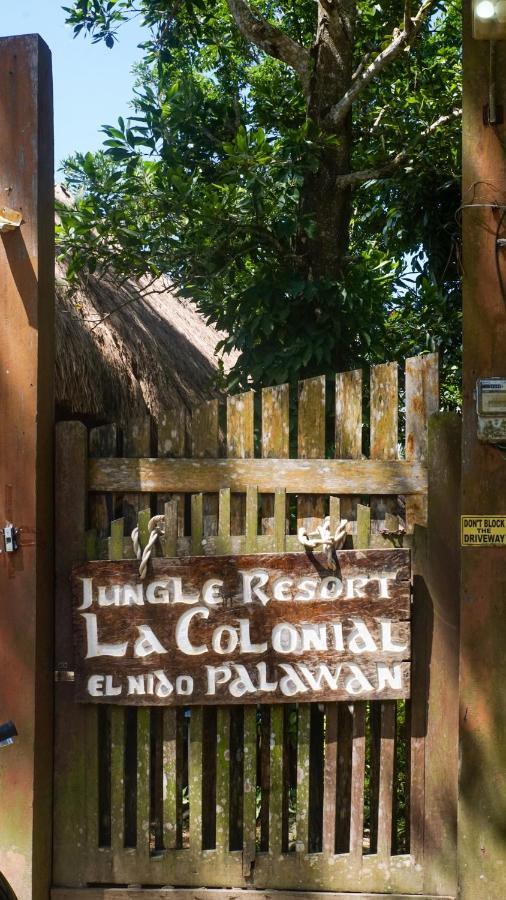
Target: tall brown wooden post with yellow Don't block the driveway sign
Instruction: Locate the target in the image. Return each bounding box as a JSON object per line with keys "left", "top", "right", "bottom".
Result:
{"left": 458, "top": 0, "right": 506, "bottom": 900}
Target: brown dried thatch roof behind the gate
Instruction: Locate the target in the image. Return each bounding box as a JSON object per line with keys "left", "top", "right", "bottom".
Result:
{"left": 56, "top": 267, "right": 237, "bottom": 422}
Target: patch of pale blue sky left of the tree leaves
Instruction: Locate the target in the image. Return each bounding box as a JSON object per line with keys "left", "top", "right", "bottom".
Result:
{"left": 0, "top": 0, "right": 145, "bottom": 170}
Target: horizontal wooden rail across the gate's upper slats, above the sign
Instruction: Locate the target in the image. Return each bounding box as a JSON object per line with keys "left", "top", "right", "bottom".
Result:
{"left": 88, "top": 459, "right": 427, "bottom": 495}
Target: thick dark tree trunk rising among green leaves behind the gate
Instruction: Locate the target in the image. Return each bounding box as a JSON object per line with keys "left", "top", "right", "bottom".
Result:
{"left": 300, "top": 0, "right": 356, "bottom": 279}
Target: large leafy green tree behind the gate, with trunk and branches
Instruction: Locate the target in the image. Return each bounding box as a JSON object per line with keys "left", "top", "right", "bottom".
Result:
{"left": 59, "top": 0, "right": 461, "bottom": 405}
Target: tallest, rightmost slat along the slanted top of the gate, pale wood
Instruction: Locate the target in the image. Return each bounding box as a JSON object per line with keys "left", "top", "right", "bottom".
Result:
{"left": 406, "top": 353, "right": 439, "bottom": 533}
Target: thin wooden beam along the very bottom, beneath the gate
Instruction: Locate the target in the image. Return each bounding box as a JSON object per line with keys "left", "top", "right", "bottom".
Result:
{"left": 51, "top": 887, "right": 455, "bottom": 900}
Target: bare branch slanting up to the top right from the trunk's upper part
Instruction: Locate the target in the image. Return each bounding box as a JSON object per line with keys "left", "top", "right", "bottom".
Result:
{"left": 326, "top": 0, "right": 440, "bottom": 128}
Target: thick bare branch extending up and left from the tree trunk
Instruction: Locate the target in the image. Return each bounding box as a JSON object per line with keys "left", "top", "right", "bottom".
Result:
{"left": 227, "top": 0, "right": 310, "bottom": 95}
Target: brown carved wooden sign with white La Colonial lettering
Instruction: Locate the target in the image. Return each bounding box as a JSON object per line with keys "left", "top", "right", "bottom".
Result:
{"left": 72, "top": 550, "right": 410, "bottom": 706}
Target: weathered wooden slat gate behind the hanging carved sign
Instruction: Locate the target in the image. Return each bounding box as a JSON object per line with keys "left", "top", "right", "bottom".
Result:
{"left": 53, "top": 355, "right": 458, "bottom": 898}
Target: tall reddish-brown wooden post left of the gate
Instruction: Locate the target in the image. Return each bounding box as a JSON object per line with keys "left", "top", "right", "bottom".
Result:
{"left": 0, "top": 35, "right": 54, "bottom": 900}
